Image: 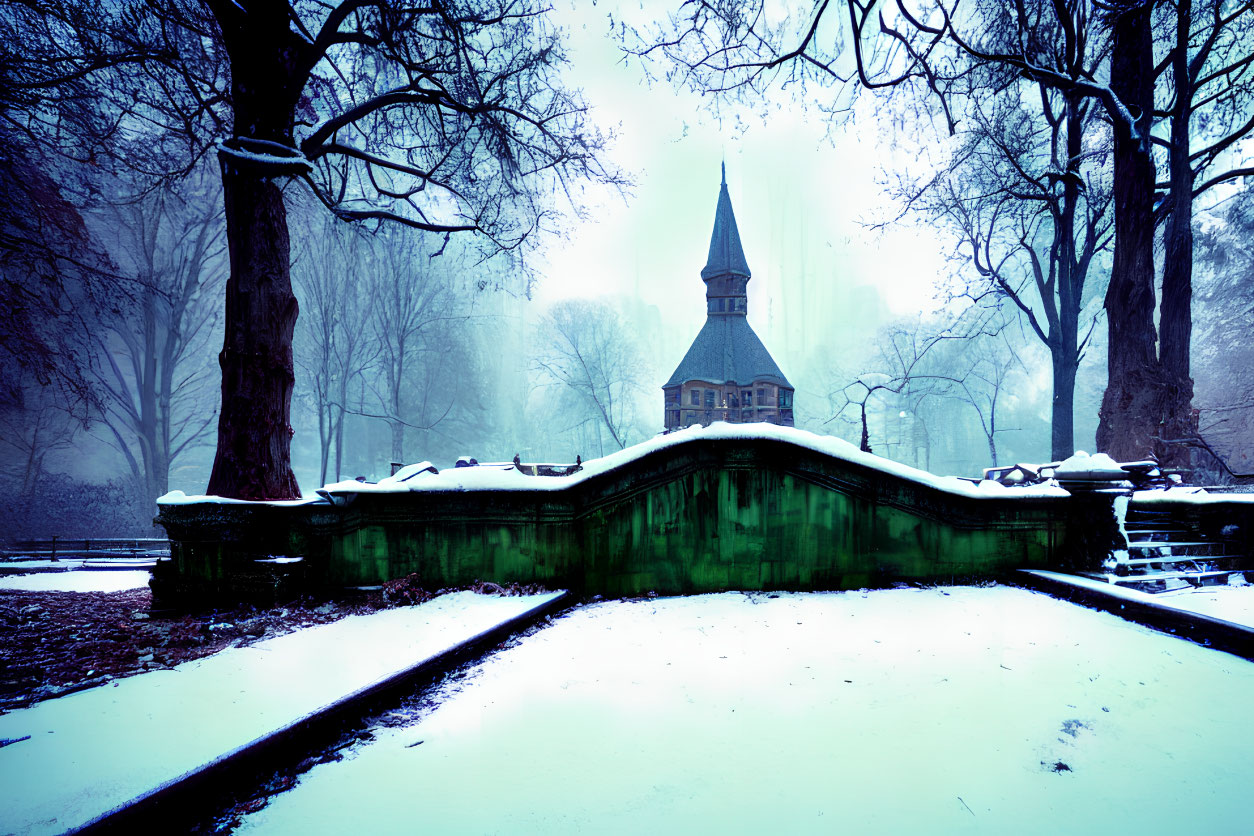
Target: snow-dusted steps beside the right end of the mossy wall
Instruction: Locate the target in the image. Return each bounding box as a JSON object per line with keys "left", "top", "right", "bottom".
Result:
{"left": 1091, "top": 508, "right": 1243, "bottom": 593}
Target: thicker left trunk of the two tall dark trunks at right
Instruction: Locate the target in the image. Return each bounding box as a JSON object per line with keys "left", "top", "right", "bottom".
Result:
{"left": 1097, "top": 3, "right": 1164, "bottom": 461}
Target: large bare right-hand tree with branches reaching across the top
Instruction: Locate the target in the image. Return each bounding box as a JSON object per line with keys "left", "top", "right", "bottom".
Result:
{"left": 623, "top": 0, "right": 1249, "bottom": 462}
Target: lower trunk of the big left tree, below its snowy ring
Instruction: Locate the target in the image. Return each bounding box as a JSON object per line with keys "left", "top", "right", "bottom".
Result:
{"left": 208, "top": 162, "right": 301, "bottom": 499}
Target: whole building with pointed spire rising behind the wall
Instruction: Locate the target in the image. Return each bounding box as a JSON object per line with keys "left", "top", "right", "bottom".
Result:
{"left": 662, "top": 164, "right": 793, "bottom": 430}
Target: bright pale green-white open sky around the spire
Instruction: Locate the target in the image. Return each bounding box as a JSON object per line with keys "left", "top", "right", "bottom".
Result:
{"left": 537, "top": 0, "right": 949, "bottom": 374}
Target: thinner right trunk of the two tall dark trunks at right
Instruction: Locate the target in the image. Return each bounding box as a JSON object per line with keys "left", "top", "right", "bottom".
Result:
{"left": 1159, "top": 0, "right": 1198, "bottom": 466}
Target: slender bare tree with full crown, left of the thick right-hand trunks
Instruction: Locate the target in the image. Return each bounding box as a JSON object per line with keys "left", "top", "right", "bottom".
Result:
{"left": 898, "top": 54, "right": 1111, "bottom": 464}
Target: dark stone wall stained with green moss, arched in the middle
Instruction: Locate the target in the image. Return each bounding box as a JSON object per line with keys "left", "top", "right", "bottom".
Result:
{"left": 159, "top": 439, "right": 1067, "bottom": 604}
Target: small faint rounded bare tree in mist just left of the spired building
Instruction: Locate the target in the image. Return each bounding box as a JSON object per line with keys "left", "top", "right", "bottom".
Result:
{"left": 534, "top": 300, "right": 645, "bottom": 450}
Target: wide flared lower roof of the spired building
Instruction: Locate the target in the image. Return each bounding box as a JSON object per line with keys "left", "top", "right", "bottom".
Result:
{"left": 665, "top": 315, "right": 793, "bottom": 389}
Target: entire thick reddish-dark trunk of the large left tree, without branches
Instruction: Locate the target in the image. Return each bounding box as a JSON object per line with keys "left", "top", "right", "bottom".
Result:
{"left": 208, "top": 0, "right": 308, "bottom": 499}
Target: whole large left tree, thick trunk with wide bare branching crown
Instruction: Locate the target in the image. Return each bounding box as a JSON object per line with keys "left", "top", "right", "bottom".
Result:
{"left": 0, "top": 0, "right": 618, "bottom": 499}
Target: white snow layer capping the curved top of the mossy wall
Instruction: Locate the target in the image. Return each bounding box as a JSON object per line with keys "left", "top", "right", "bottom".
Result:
{"left": 157, "top": 421, "right": 1068, "bottom": 505}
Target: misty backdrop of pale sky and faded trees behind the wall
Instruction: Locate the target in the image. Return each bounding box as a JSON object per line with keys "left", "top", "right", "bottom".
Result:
{"left": 0, "top": 3, "right": 1254, "bottom": 536}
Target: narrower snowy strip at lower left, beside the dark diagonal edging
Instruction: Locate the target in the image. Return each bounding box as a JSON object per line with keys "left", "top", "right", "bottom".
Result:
{"left": 0, "top": 592, "right": 562, "bottom": 833}
